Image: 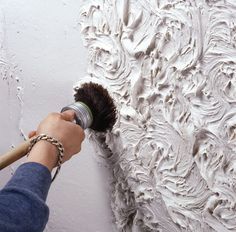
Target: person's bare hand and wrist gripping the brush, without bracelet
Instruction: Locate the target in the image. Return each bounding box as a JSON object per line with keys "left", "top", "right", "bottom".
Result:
{"left": 26, "top": 110, "right": 85, "bottom": 170}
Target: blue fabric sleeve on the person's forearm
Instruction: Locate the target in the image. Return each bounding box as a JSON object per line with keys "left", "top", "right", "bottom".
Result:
{"left": 0, "top": 162, "right": 51, "bottom": 232}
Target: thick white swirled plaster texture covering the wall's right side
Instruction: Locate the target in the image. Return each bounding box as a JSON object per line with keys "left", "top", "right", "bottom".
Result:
{"left": 80, "top": 0, "right": 236, "bottom": 232}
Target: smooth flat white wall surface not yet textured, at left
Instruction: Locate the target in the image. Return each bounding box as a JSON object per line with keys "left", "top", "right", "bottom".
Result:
{"left": 0, "top": 0, "right": 115, "bottom": 232}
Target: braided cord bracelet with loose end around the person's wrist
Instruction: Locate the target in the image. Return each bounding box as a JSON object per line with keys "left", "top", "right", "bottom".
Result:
{"left": 28, "top": 134, "right": 64, "bottom": 182}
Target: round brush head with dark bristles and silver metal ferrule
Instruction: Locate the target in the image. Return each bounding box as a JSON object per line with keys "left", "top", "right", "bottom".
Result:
{"left": 62, "top": 82, "right": 116, "bottom": 132}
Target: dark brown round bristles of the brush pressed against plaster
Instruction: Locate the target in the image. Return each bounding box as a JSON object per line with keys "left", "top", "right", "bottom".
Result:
{"left": 74, "top": 82, "right": 116, "bottom": 132}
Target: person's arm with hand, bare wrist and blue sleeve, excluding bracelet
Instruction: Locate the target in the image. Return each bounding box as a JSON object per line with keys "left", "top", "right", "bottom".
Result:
{"left": 0, "top": 111, "right": 84, "bottom": 232}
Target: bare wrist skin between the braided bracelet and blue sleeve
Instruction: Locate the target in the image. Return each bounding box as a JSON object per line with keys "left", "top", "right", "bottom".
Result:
{"left": 27, "top": 140, "right": 58, "bottom": 171}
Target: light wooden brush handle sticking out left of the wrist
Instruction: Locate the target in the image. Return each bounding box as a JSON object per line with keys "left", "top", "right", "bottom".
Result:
{"left": 0, "top": 140, "right": 30, "bottom": 170}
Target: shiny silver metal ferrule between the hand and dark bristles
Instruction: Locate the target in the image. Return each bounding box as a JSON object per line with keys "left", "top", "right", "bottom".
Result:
{"left": 61, "top": 102, "right": 93, "bottom": 129}
